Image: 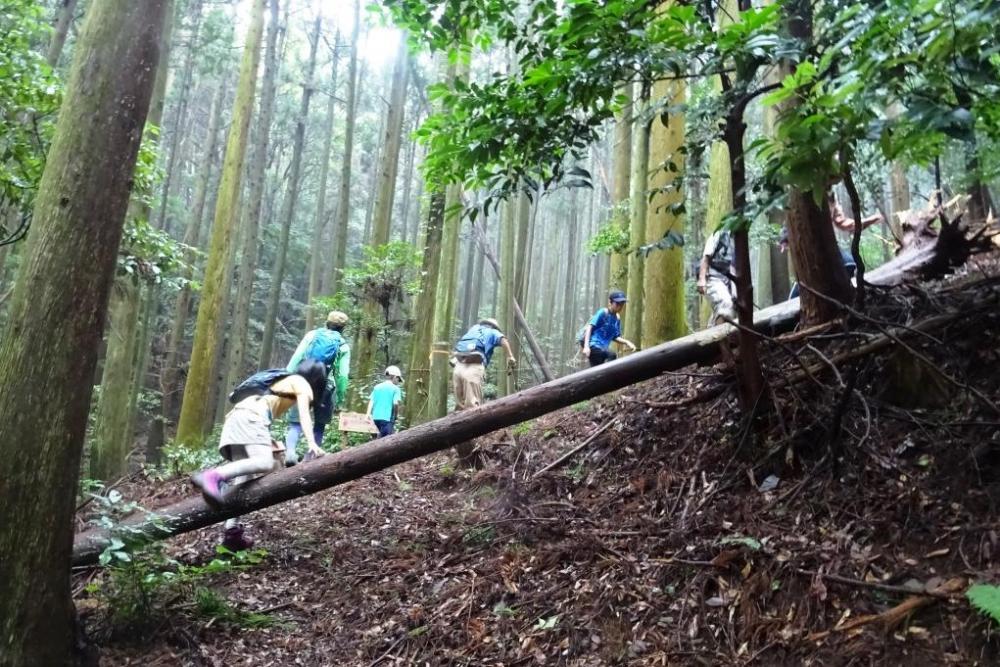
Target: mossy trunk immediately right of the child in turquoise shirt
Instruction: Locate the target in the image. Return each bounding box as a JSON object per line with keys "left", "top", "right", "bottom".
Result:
{"left": 403, "top": 192, "right": 444, "bottom": 426}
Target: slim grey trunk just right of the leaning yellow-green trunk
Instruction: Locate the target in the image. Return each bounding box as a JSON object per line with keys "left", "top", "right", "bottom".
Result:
{"left": 225, "top": 0, "right": 282, "bottom": 402}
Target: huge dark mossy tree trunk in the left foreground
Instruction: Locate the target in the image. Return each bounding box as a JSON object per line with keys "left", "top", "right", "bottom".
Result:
{"left": 0, "top": 0, "right": 167, "bottom": 665}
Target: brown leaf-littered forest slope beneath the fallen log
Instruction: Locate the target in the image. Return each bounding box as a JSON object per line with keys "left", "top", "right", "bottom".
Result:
{"left": 77, "top": 261, "right": 1000, "bottom": 667}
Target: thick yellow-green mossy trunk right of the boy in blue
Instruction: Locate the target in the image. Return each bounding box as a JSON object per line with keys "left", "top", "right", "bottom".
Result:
{"left": 642, "top": 81, "right": 687, "bottom": 347}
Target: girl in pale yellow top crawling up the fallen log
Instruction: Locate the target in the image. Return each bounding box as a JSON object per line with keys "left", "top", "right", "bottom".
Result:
{"left": 191, "top": 360, "right": 326, "bottom": 550}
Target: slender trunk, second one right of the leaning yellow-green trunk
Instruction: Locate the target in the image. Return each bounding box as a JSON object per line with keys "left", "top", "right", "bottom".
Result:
{"left": 258, "top": 17, "right": 322, "bottom": 368}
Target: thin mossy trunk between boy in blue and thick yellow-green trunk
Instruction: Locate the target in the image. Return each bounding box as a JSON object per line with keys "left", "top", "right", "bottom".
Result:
{"left": 624, "top": 97, "right": 652, "bottom": 349}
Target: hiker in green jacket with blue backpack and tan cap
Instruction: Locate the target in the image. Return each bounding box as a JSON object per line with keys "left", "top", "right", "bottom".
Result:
{"left": 285, "top": 310, "right": 351, "bottom": 465}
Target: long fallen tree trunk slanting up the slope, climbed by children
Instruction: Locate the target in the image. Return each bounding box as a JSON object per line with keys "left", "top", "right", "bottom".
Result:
{"left": 72, "top": 230, "right": 984, "bottom": 565}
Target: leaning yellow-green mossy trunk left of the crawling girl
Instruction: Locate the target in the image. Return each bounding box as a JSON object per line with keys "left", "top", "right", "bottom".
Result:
{"left": 177, "top": 0, "right": 265, "bottom": 445}
